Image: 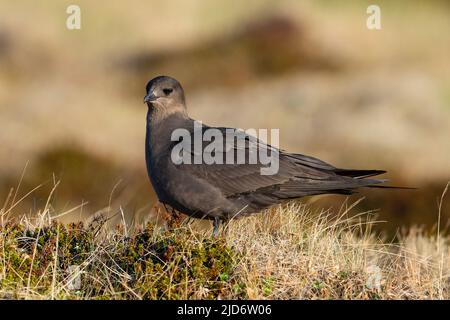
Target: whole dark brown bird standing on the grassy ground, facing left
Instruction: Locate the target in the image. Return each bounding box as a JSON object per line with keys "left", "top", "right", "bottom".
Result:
{"left": 144, "top": 76, "right": 386, "bottom": 232}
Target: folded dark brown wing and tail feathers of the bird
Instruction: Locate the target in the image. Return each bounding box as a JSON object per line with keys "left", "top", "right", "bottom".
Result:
{"left": 171, "top": 126, "right": 384, "bottom": 201}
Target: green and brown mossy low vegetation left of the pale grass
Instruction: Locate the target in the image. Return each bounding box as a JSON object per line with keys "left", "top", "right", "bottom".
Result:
{"left": 0, "top": 222, "right": 244, "bottom": 299}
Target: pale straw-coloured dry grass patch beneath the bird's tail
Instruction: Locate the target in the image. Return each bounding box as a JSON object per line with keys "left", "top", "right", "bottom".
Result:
{"left": 230, "top": 205, "right": 450, "bottom": 299}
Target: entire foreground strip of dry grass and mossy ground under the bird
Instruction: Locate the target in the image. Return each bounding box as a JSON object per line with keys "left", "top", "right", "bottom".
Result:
{"left": 0, "top": 188, "right": 450, "bottom": 299}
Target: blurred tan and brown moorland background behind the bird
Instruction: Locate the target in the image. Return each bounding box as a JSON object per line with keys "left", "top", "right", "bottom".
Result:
{"left": 0, "top": 0, "right": 450, "bottom": 235}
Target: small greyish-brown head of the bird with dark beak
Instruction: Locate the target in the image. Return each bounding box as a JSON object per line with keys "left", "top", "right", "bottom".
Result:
{"left": 144, "top": 76, "right": 186, "bottom": 114}
